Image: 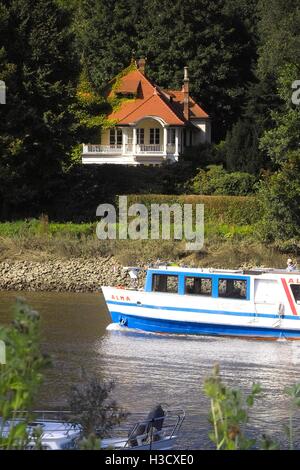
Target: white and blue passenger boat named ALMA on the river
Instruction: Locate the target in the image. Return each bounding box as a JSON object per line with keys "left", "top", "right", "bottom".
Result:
{"left": 102, "top": 265, "right": 300, "bottom": 339}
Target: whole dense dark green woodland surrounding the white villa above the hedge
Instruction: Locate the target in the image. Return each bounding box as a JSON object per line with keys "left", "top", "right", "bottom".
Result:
{"left": 0, "top": 0, "right": 300, "bottom": 245}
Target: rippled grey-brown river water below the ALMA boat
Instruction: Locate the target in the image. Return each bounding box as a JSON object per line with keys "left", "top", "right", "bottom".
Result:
{"left": 0, "top": 292, "right": 300, "bottom": 450}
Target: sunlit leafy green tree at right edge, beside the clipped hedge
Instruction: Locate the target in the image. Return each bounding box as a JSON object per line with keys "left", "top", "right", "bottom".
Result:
{"left": 260, "top": 65, "right": 300, "bottom": 242}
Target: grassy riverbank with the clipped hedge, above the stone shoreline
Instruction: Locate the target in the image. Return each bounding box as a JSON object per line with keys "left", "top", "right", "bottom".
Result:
{"left": 0, "top": 194, "right": 287, "bottom": 268}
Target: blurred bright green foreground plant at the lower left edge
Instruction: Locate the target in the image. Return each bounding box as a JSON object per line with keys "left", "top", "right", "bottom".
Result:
{"left": 0, "top": 300, "right": 48, "bottom": 449}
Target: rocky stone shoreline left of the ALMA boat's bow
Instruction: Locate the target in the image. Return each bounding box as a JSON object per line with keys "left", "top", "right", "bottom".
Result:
{"left": 0, "top": 256, "right": 144, "bottom": 292}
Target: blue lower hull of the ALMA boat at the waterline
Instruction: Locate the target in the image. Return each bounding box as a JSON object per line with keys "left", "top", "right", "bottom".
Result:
{"left": 110, "top": 311, "right": 300, "bottom": 340}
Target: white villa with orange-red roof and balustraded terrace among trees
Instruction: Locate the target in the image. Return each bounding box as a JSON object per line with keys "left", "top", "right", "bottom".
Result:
{"left": 82, "top": 59, "right": 211, "bottom": 165}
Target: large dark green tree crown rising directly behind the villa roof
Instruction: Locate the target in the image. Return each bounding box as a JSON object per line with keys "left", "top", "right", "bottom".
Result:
{"left": 76, "top": 0, "right": 255, "bottom": 140}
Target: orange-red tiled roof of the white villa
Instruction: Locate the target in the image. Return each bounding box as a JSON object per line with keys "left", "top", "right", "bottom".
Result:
{"left": 108, "top": 70, "right": 208, "bottom": 126}
